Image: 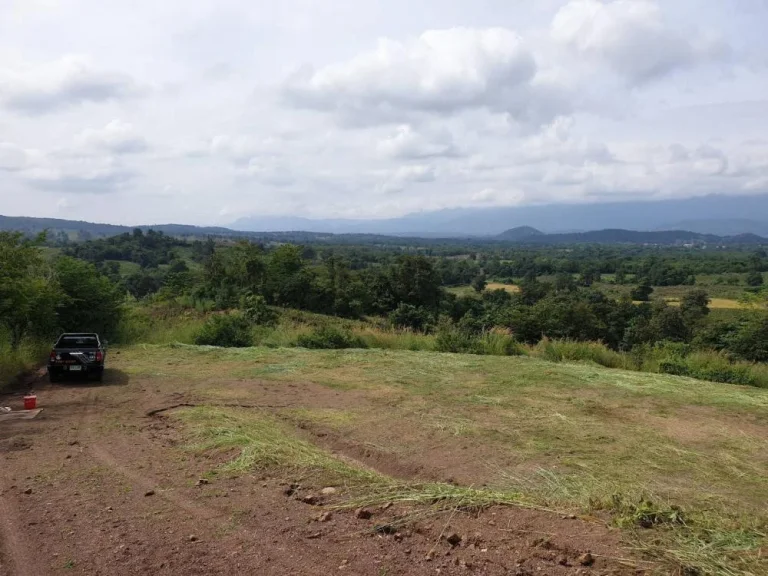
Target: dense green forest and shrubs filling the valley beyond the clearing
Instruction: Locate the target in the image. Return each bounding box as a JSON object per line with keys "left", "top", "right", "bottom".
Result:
{"left": 0, "top": 229, "right": 768, "bottom": 390}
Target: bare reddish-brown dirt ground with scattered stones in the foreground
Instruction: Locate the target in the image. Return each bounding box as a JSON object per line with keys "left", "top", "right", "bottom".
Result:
{"left": 0, "top": 370, "right": 639, "bottom": 576}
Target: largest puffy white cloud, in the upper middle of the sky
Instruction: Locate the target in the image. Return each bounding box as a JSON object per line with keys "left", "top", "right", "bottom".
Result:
{"left": 284, "top": 28, "right": 564, "bottom": 125}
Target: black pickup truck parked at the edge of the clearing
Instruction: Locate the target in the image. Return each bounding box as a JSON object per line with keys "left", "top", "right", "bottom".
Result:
{"left": 48, "top": 333, "right": 107, "bottom": 382}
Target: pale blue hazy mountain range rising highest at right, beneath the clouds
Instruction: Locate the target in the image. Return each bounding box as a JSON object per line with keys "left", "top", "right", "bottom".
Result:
{"left": 232, "top": 195, "right": 768, "bottom": 237}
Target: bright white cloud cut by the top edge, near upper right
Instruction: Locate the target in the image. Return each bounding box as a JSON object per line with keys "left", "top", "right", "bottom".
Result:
{"left": 552, "top": 0, "right": 730, "bottom": 85}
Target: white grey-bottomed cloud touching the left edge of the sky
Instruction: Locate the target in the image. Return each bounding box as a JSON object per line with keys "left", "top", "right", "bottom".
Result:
{"left": 0, "top": 55, "right": 142, "bottom": 114}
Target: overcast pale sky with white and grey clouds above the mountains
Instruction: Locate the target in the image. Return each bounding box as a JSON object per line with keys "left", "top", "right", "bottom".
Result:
{"left": 0, "top": 0, "right": 768, "bottom": 225}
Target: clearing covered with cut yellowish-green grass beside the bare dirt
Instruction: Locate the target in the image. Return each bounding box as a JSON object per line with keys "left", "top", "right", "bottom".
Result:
{"left": 113, "top": 345, "right": 768, "bottom": 575}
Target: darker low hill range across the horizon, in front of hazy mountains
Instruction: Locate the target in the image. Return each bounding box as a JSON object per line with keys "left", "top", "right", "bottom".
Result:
{"left": 0, "top": 216, "right": 768, "bottom": 245}
